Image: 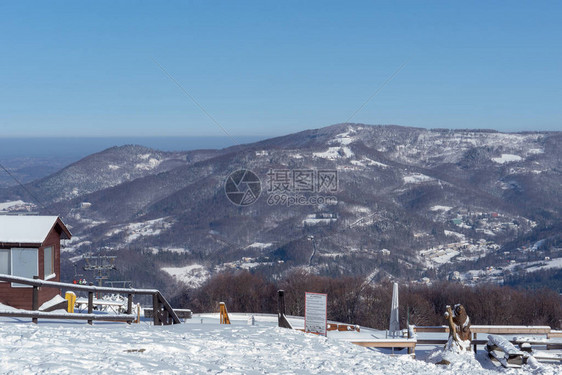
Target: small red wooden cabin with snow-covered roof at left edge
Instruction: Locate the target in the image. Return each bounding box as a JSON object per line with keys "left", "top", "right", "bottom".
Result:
{"left": 0, "top": 215, "right": 72, "bottom": 310}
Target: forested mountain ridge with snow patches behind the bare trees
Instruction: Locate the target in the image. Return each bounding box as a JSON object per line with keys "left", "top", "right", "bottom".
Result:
{"left": 0, "top": 124, "right": 562, "bottom": 296}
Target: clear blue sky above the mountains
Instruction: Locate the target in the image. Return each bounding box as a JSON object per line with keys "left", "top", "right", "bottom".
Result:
{"left": 0, "top": 0, "right": 562, "bottom": 136}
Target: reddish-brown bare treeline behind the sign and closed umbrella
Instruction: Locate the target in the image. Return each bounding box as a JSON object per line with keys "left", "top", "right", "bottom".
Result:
{"left": 172, "top": 270, "right": 562, "bottom": 329}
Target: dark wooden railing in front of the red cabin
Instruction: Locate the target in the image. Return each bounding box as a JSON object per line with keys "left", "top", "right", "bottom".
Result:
{"left": 0, "top": 274, "right": 181, "bottom": 325}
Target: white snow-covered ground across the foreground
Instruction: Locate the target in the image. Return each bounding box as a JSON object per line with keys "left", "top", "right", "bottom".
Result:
{"left": 0, "top": 314, "right": 562, "bottom": 375}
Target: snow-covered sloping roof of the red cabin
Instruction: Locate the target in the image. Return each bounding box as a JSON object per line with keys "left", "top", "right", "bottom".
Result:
{"left": 0, "top": 215, "right": 70, "bottom": 244}
